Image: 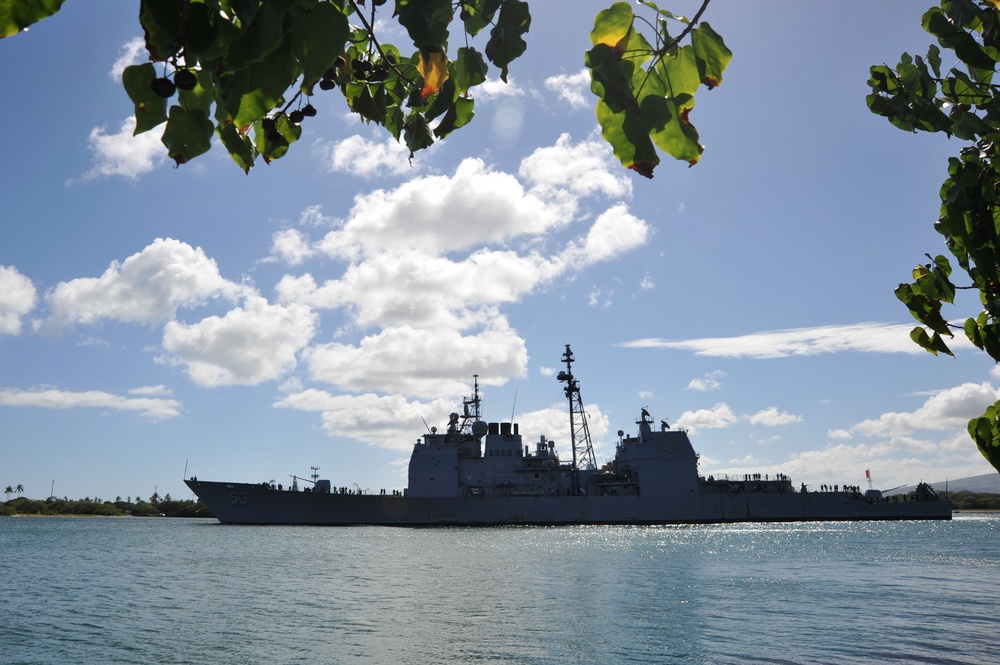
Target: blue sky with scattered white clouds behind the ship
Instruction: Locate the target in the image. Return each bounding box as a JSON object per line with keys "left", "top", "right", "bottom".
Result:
{"left": 0, "top": 0, "right": 1000, "bottom": 499}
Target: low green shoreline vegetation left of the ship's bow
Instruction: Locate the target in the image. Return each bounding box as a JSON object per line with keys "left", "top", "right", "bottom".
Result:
{"left": 0, "top": 493, "right": 213, "bottom": 517}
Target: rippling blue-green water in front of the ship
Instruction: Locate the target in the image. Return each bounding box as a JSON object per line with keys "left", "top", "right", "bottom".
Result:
{"left": 0, "top": 513, "right": 1000, "bottom": 665}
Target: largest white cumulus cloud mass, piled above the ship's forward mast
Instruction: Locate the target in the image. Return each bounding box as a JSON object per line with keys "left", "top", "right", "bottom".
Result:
{"left": 272, "top": 136, "right": 651, "bottom": 431}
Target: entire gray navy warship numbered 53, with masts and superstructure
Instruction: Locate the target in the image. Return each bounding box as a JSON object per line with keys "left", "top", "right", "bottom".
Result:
{"left": 184, "top": 344, "right": 952, "bottom": 526}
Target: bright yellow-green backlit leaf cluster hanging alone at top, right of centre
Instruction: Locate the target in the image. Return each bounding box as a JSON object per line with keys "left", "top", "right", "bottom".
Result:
{"left": 586, "top": 0, "right": 732, "bottom": 178}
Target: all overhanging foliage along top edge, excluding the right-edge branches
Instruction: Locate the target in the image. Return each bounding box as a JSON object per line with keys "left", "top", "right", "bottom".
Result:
{"left": 0, "top": 0, "right": 732, "bottom": 177}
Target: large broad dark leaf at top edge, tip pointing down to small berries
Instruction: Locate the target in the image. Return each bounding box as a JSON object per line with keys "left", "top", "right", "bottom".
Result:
{"left": 289, "top": 2, "right": 350, "bottom": 90}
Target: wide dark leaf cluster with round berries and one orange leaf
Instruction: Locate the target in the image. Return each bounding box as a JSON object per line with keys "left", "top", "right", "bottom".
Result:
{"left": 123, "top": 0, "right": 531, "bottom": 172}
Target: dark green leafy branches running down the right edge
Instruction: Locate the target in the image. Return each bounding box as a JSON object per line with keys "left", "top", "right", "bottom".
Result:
{"left": 867, "top": 0, "right": 1000, "bottom": 469}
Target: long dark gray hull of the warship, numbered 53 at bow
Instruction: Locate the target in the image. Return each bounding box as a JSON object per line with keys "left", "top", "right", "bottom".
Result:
{"left": 185, "top": 479, "right": 952, "bottom": 526}
